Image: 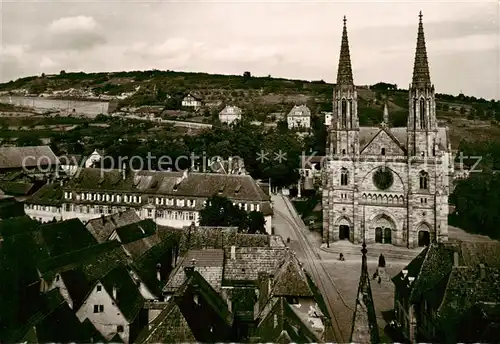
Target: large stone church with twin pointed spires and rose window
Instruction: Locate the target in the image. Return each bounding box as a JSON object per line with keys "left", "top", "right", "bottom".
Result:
{"left": 322, "top": 13, "right": 453, "bottom": 248}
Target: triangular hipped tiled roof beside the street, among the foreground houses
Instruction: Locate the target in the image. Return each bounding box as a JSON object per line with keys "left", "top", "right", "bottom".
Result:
{"left": 271, "top": 250, "right": 313, "bottom": 297}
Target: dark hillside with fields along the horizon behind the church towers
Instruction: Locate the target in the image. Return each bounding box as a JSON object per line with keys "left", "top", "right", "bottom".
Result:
{"left": 0, "top": 70, "right": 500, "bottom": 147}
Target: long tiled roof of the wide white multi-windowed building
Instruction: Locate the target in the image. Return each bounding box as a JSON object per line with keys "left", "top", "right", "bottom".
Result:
{"left": 66, "top": 168, "right": 269, "bottom": 201}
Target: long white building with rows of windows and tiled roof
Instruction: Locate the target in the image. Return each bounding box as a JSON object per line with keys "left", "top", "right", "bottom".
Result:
{"left": 26, "top": 168, "right": 273, "bottom": 233}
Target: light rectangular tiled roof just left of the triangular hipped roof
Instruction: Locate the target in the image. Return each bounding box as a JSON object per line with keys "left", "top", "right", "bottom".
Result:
{"left": 223, "top": 247, "right": 286, "bottom": 283}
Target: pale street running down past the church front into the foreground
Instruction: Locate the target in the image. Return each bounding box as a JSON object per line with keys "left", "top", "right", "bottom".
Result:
{"left": 272, "top": 194, "right": 418, "bottom": 343}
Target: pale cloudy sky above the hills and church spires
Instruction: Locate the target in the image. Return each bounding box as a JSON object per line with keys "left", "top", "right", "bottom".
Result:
{"left": 0, "top": 0, "right": 500, "bottom": 100}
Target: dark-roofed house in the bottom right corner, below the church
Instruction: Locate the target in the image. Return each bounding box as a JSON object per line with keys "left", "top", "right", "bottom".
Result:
{"left": 392, "top": 242, "right": 500, "bottom": 343}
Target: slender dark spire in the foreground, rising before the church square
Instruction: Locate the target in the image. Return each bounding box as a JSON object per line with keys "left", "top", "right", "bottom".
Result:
{"left": 350, "top": 239, "right": 380, "bottom": 343}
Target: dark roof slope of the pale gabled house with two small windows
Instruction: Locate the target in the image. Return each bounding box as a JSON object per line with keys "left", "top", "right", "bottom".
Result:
{"left": 100, "top": 266, "right": 144, "bottom": 323}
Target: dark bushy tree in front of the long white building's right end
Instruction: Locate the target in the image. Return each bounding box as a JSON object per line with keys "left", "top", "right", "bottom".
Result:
{"left": 200, "top": 195, "right": 248, "bottom": 231}
